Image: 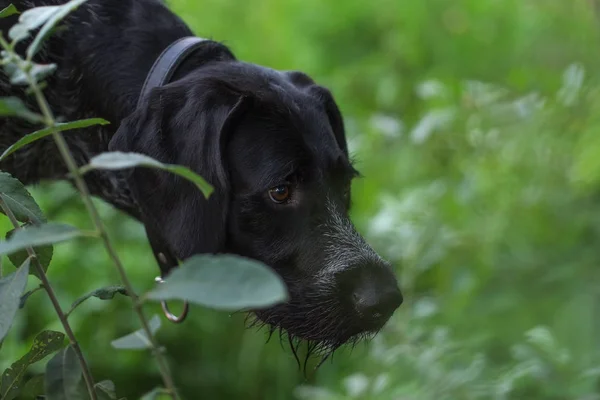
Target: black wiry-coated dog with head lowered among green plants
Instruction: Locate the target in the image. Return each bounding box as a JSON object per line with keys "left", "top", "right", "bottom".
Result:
{"left": 0, "top": 0, "right": 402, "bottom": 356}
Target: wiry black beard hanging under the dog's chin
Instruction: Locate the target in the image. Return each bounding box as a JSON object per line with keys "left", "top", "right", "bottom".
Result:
{"left": 247, "top": 282, "right": 377, "bottom": 375}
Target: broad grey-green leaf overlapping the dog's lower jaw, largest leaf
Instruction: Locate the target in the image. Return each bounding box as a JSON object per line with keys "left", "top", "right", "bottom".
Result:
{"left": 145, "top": 254, "right": 288, "bottom": 311}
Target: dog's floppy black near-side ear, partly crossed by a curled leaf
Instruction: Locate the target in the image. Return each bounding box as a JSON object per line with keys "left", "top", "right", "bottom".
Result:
{"left": 109, "top": 79, "right": 248, "bottom": 260}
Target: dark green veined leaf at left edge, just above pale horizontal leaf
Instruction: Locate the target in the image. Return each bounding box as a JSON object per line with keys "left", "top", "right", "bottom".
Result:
{"left": 0, "top": 172, "right": 46, "bottom": 224}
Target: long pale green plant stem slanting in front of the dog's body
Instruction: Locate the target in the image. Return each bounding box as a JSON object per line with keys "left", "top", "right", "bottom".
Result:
{"left": 23, "top": 58, "right": 177, "bottom": 400}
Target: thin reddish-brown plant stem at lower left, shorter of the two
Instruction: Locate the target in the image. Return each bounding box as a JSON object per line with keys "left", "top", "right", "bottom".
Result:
{"left": 0, "top": 195, "right": 98, "bottom": 400}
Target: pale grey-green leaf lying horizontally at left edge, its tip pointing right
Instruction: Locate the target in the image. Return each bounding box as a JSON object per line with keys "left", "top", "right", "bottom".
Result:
{"left": 0, "top": 223, "right": 82, "bottom": 255}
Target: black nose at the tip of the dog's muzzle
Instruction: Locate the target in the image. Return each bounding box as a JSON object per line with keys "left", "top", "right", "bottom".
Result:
{"left": 338, "top": 263, "right": 403, "bottom": 330}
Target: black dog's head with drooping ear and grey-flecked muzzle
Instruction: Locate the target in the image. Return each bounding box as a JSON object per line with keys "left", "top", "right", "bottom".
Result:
{"left": 110, "top": 61, "right": 402, "bottom": 349}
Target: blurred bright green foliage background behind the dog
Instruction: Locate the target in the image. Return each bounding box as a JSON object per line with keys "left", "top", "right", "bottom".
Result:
{"left": 0, "top": 0, "right": 600, "bottom": 400}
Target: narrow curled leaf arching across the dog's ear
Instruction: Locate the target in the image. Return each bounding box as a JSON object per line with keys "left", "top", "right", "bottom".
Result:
{"left": 81, "top": 151, "right": 214, "bottom": 198}
